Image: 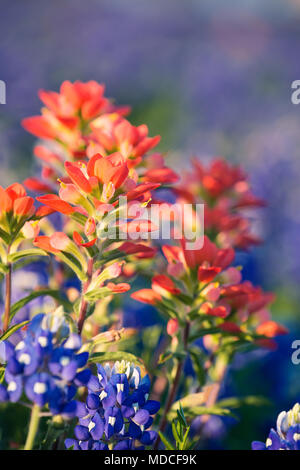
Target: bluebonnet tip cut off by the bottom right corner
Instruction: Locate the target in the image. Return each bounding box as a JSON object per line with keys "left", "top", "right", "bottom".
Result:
{"left": 252, "top": 403, "right": 300, "bottom": 450}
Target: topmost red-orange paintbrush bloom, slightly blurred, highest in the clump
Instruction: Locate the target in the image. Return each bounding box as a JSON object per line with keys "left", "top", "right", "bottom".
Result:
{"left": 22, "top": 80, "right": 129, "bottom": 163}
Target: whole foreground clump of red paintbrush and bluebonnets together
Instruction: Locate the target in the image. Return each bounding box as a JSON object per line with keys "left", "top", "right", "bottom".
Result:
{"left": 0, "top": 81, "right": 290, "bottom": 450}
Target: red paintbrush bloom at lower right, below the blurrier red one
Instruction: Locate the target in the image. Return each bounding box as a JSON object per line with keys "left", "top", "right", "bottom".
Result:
{"left": 131, "top": 236, "right": 287, "bottom": 348}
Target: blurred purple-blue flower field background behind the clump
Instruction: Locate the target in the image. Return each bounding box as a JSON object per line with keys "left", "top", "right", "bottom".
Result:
{"left": 0, "top": 0, "right": 300, "bottom": 449}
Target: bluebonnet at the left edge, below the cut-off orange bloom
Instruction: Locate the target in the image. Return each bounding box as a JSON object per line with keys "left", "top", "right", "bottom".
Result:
{"left": 0, "top": 309, "right": 91, "bottom": 417}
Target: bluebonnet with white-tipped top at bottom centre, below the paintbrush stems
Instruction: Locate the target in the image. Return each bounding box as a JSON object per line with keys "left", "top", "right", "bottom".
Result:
{"left": 65, "top": 361, "right": 160, "bottom": 450}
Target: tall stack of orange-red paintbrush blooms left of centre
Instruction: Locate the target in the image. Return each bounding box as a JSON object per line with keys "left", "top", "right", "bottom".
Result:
{"left": 23, "top": 81, "right": 178, "bottom": 316}
